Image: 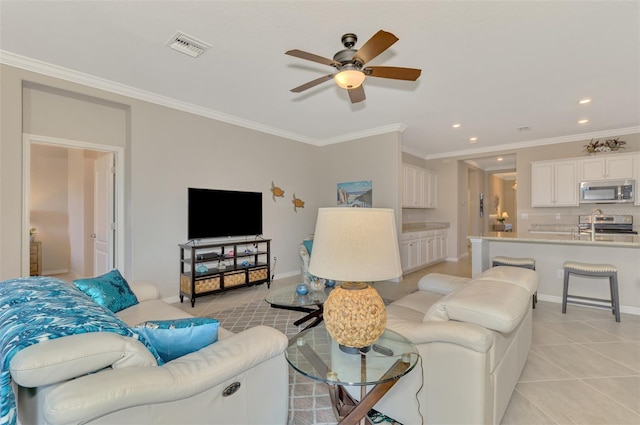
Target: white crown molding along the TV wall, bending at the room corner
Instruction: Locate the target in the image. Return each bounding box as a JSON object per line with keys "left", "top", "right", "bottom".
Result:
{"left": 0, "top": 50, "right": 407, "bottom": 146}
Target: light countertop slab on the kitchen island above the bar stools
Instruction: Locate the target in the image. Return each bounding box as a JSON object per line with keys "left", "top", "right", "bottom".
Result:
{"left": 468, "top": 232, "right": 640, "bottom": 248}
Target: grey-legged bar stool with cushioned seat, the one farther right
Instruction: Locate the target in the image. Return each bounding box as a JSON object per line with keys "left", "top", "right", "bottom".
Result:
{"left": 562, "top": 261, "right": 620, "bottom": 322}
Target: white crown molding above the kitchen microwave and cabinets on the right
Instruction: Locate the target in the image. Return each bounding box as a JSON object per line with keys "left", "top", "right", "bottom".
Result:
{"left": 420, "top": 126, "right": 640, "bottom": 160}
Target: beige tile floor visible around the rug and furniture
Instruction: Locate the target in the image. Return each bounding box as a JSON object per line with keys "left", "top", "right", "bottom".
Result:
{"left": 172, "top": 259, "right": 640, "bottom": 425}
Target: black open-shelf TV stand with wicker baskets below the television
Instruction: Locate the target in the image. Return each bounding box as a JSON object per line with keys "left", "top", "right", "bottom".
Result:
{"left": 179, "top": 239, "right": 271, "bottom": 307}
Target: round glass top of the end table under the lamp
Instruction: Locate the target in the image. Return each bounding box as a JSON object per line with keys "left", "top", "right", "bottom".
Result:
{"left": 285, "top": 326, "right": 418, "bottom": 385}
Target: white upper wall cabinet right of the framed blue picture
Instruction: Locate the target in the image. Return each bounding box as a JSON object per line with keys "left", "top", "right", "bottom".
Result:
{"left": 402, "top": 164, "right": 438, "bottom": 208}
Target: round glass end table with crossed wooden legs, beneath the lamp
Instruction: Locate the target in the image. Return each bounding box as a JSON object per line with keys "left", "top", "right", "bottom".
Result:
{"left": 285, "top": 326, "right": 419, "bottom": 425}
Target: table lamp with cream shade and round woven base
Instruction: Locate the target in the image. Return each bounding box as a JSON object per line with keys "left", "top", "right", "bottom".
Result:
{"left": 309, "top": 208, "right": 402, "bottom": 354}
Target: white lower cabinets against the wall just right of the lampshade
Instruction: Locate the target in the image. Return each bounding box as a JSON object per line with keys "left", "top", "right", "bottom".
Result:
{"left": 400, "top": 229, "right": 449, "bottom": 273}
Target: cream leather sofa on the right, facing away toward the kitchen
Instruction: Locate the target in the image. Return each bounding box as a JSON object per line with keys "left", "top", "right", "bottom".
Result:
{"left": 375, "top": 267, "right": 538, "bottom": 424}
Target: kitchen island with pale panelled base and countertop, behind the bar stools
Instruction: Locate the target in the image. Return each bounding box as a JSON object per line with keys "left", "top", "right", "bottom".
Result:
{"left": 469, "top": 232, "right": 640, "bottom": 315}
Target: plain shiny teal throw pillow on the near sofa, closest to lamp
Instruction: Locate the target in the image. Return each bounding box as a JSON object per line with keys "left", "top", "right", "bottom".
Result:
{"left": 133, "top": 317, "right": 220, "bottom": 362}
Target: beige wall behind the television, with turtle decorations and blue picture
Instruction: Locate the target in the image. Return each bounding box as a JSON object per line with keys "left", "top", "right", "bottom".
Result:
{"left": 0, "top": 65, "right": 401, "bottom": 297}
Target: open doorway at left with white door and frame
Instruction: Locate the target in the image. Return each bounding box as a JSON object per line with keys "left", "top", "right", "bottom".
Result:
{"left": 23, "top": 135, "right": 124, "bottom": 282}
